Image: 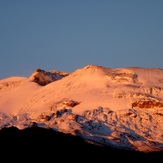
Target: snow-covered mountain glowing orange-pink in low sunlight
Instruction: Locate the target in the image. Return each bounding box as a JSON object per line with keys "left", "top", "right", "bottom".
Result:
{"left": 0, "top": 65, "right": 163, "bottom": 153}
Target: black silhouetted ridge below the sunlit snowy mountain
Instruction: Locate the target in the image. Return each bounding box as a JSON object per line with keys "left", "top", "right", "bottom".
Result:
{"left": 0, "top": 127, "right": 163, "bottom": 162}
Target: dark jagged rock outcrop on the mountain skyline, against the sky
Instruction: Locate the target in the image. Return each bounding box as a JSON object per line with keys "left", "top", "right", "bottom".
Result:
{"left": 29, "top": 68, "right": 69, "bottom": 86}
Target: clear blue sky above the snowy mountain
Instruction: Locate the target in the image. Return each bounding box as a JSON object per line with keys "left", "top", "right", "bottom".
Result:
{"left": 0, "top": 0, "right": 163, "bottom": 79}
